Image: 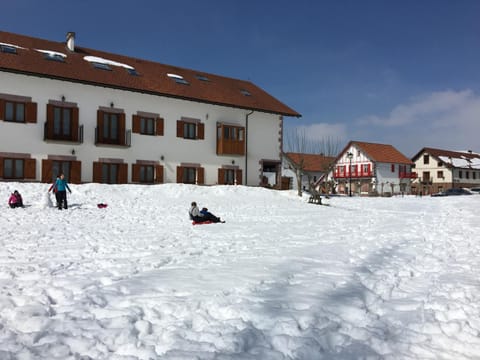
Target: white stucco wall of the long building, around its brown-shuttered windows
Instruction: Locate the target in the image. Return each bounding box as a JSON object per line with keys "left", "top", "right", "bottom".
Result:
{"left": 0, "top": 70, "right": 281, "bottom": 185}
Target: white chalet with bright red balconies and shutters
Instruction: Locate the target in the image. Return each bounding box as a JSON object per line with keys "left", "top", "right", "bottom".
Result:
{"left": 332, "top": 141, "right": 416, "bottom": 196}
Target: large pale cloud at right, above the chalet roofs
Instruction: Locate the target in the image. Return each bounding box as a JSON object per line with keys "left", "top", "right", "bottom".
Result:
{"left": 349, "top": 89, "right": 480, "bottom": 154}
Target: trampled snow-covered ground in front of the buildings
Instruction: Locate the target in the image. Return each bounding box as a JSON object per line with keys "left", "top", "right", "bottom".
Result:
{"left": 0, "top": 183, "right": 480, "bottom": 360}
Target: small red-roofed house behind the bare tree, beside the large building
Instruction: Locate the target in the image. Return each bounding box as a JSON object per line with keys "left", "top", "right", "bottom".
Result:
{"left": 283, "top": 152, "right": 335, "bottom": 190}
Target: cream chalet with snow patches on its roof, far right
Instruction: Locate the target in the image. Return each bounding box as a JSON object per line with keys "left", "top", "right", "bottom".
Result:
{"left": 412, "top": 147, "right": 480, "bottom": 194}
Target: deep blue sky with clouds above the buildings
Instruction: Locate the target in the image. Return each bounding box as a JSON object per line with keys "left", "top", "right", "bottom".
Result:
{"left": 0, "top": 0, "right": 480, "bottom": 156}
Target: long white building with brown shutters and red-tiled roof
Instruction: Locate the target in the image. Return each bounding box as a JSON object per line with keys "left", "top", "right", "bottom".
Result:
{"left": 0, "top": 32, "right": 300, "bottom": 186}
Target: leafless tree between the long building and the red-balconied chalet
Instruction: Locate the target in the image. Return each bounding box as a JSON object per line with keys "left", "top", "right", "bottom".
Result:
{"left": 282, "top": 128, "right": 340, "bottom": 196}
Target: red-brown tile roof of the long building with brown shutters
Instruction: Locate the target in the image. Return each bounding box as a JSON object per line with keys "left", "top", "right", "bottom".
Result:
{"left": 0, "top": 31, "right": 301, "bottom": 117}
